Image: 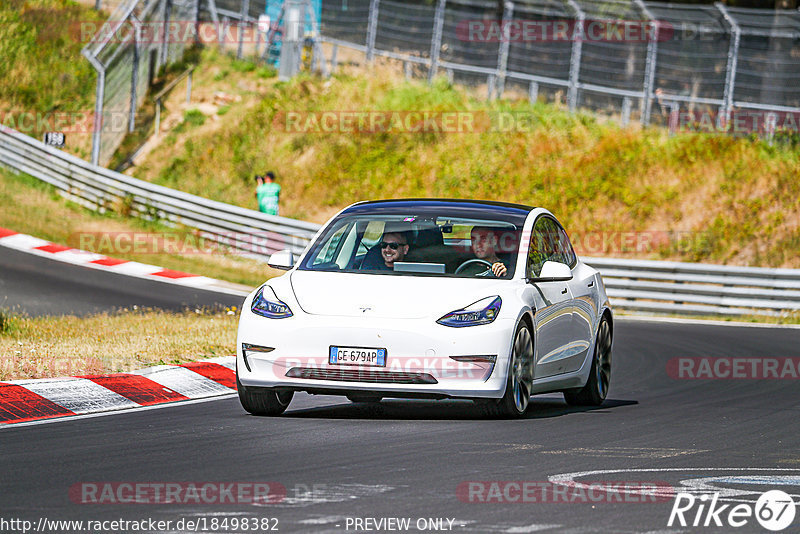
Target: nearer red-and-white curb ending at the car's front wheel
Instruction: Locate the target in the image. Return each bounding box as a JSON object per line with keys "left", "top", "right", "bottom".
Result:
{"left": 0, "top": 356, "right": 236, "bottom": 426}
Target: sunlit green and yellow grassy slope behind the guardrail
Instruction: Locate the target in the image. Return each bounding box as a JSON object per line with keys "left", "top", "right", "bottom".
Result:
{"left": 136, "top": 53, "right": 800, "bottom": 267}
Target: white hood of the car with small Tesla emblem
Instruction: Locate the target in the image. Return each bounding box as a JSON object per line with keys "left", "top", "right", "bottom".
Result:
{"left": 291, "top": 271, "right": 509, "bottom": 319}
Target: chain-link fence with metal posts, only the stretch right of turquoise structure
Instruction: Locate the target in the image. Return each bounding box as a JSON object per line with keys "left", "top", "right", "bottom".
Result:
{"left": 320, "top": 0, "right": 800, "bottom": 125}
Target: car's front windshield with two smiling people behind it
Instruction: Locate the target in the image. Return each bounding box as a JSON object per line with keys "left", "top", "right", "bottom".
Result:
{"left": 298, "top": 206, "right": 525, "bottom": 278}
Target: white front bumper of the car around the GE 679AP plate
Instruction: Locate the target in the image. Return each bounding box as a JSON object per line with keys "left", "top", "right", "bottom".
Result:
{"left": 236, "top": 307, "right": 516, "bottom": 398}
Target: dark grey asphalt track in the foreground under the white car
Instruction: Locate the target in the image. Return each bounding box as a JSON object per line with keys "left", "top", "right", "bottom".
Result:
{"left": 0, "top": 252, "right": 800, "bottom": 533}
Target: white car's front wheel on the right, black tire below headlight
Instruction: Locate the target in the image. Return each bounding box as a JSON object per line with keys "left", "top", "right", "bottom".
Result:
{"left": 486, "top": 323, "right": 533, "bottom": 419}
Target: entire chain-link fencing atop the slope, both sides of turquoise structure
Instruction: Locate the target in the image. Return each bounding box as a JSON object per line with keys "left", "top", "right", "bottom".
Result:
{"left": 84, "top": 0, "right": 800, "bottom": 162}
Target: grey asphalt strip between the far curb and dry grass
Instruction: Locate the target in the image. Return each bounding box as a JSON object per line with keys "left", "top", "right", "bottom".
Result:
{"left": 0, "top": 247, "right": 244, "bottom": 316}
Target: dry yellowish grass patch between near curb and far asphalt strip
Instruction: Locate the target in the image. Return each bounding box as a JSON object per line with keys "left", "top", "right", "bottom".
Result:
{"left": 0, "top": 309, "right": 238, "bottom": 380}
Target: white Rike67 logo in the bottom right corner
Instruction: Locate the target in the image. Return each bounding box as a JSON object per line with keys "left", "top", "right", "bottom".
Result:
{"left": 667, "top": 490, "right": 796, "bottom": 532}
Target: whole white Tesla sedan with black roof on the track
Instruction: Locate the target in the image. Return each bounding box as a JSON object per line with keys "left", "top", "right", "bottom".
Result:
{"left": 236, "top": 199, "right": 613, "bottom": 417}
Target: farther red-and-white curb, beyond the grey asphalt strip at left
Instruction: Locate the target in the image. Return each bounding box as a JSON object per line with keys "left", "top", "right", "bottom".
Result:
{"left": 0, "top": 227, "right": 249, "bottom": 296}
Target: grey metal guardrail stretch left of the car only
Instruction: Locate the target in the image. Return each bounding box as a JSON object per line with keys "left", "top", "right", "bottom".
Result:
{"left": 0, "top": 129, "right": 319, "bottom": 259}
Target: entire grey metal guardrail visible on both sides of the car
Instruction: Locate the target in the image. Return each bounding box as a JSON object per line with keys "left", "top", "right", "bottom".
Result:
{"left": 0, "top": 129, "right": 800, "bottom": 315}
